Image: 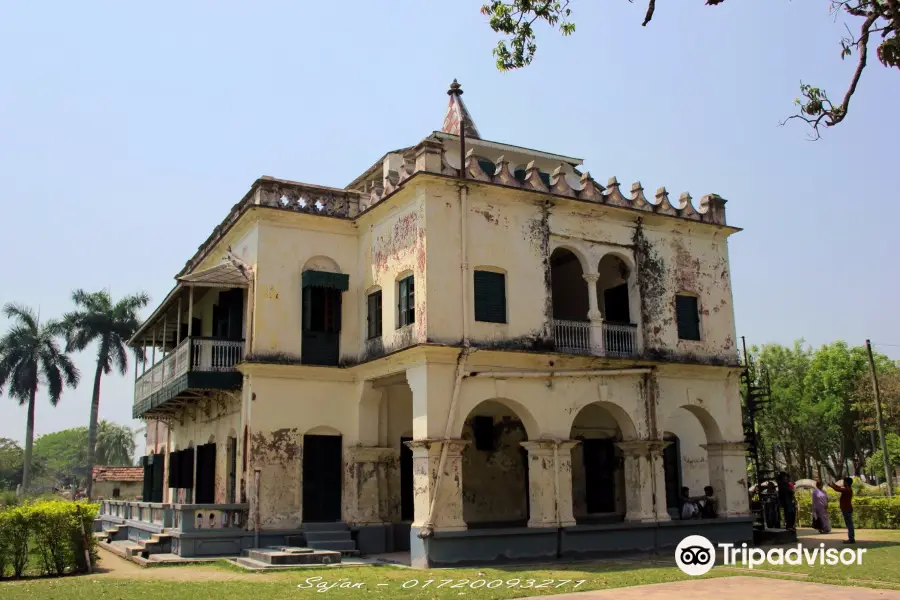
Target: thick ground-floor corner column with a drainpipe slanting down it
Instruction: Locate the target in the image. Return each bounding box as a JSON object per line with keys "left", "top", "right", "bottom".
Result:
{"left": 406, "top": 439, "right": 469, "bottom": 531}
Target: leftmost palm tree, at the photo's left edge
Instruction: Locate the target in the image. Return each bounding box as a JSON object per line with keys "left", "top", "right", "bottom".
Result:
{"left": 0, "top": 304, "right": 80, "bottom": 491}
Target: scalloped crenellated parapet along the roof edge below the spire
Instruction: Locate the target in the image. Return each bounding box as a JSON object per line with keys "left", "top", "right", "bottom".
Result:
{"left": 359, "top": 137, "right": 725, "bottom": 225}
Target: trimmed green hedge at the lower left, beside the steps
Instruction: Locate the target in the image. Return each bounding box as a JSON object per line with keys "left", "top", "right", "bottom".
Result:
{"left": 0, "top": 500, "right": 99, "bottom": 578}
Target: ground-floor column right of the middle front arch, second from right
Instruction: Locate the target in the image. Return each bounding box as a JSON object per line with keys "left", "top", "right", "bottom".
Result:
{"left": 616, "top": 440, "right": 669, "bottom": 523}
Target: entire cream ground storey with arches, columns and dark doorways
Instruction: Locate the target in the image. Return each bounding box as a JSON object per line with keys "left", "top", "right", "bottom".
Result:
{"left": 128, "top": 348, "right": 751, "bottom": 565}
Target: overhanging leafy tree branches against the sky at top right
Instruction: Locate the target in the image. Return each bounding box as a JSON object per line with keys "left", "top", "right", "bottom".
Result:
{"left": 481, "top": 0, "right": 900, "bottom": 139}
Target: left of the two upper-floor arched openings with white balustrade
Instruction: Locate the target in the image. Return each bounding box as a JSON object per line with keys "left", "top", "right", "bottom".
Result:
{"left": 550, "top": 248, "right": 590, "bottom": 352}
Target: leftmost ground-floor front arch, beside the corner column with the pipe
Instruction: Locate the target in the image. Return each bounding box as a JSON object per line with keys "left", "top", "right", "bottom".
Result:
{"left": 461, "top": 400, "right": 530, "bottom": 528}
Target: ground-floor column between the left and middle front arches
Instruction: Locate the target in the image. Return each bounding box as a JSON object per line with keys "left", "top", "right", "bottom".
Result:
{"left": 520, "top": 440, "right": 578, "bottom": 527}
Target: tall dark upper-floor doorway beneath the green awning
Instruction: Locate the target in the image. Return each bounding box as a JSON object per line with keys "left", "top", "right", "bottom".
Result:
{"left": 300, "top": 287, "right": 341, "bottom": 365}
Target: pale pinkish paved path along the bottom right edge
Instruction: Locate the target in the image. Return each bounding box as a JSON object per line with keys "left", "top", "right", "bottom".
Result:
{"left": 523, "top": 576, "right": 900, "bottom": 600}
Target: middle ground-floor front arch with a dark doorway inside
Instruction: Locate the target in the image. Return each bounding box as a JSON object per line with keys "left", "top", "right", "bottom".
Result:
{"left": 570, "top": 402, "right": 634, "bottom": 523}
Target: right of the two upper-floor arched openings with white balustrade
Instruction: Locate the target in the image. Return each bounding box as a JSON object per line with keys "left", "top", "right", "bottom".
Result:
{"left": 597, "top": 254, "right": 637, "bottom": 356}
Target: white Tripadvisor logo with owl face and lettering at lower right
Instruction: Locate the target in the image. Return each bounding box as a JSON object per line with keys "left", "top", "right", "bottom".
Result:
{"left": 675, "top": 535, "right": 866, "bottom": 577}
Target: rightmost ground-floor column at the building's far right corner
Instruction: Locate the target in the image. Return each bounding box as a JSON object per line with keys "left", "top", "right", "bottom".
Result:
{"left": 700, "top": 442, "right": 750, "bottom": 517}
